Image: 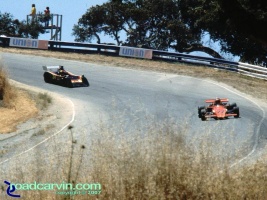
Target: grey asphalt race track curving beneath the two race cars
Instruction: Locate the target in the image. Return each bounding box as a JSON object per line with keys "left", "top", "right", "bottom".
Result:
{"left": 1, "top": 53, "right": 267, "bottom": 167}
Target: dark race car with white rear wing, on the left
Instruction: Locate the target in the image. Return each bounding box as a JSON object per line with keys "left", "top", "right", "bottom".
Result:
{"left": 43, "top": 66, "right": 89, "bottom": 88}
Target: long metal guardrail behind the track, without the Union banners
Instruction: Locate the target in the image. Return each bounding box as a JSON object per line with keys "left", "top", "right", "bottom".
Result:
{"left": 0, "top": 37, "right": 267, "bottom": 80}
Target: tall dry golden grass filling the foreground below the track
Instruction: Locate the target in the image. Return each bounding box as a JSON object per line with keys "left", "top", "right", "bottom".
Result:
{"left": 2, "top": 119, "right": 267, "bottom": 200}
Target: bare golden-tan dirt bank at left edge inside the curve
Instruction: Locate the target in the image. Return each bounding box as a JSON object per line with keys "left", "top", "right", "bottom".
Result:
{"left": 0, "top": 89, "right": 38, "bottom": 133}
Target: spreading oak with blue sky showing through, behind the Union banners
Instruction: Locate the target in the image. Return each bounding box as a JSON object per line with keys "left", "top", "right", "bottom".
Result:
{"left": 73, "top": 0, "right": 221, "bottom": 58}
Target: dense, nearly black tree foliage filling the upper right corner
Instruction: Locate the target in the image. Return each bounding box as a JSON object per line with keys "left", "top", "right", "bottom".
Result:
{"left": 180, "top": 0, "right": 267, "bottom": 63}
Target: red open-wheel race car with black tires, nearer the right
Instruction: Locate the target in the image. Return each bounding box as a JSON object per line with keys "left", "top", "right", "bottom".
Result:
{"left": 198, "top": 98, "right": 239, "bottom": 121}
